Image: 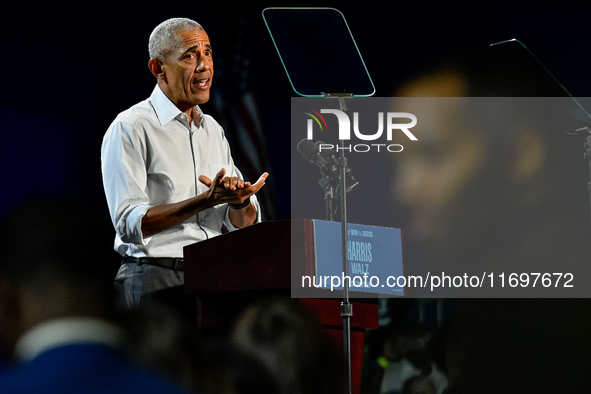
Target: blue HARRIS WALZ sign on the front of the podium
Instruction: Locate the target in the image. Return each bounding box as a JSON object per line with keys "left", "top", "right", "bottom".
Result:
{"left": 313, "top": 220, "right": 404, "bottom": 295}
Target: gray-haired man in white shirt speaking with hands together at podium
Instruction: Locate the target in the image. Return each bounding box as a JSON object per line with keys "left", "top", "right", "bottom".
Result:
{"left": 101, "top": 18, "right": 268, "bottom": 308}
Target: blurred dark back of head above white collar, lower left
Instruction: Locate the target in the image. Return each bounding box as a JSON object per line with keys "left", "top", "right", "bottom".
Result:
{"left": 0, "top": 195, "right": 115, "bottom": 353}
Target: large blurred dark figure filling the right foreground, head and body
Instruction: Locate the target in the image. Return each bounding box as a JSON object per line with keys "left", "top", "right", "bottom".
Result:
{"left": 392, "top": 47, "right": 591, "bottom": 394}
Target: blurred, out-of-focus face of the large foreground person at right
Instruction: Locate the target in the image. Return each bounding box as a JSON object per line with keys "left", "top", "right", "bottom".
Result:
{"left": 393, "top": 75, "right": 487, "bottom": 240}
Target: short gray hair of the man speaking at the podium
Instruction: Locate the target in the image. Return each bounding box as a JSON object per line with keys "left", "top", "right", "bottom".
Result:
{"left": 148, "top": 18, "right": 203, "bottom": 61}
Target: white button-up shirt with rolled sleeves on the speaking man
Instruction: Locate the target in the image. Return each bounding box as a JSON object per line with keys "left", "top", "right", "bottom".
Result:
{"left": 101, "top": 85, "right": 261, "bottom": 257}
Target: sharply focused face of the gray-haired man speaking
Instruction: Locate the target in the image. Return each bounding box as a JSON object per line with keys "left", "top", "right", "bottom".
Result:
{"left": 162, "top": 30, "right": 213, "bottom": 111}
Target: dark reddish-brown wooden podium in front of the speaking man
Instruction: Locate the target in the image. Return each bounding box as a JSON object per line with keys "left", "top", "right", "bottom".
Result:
{"left": 184, "top": 220, "right": 378, "bottom": 393}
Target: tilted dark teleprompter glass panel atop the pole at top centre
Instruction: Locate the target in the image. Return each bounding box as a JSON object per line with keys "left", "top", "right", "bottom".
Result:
{"left": 263, "top": 8, "right": 375, "bottom": 97}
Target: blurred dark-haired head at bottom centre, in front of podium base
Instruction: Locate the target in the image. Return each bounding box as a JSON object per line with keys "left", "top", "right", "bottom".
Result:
{"left": 232, "top": 299, "right": 346, "bottom": 394}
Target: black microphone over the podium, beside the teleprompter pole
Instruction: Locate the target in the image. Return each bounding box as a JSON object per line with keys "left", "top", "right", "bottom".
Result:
{"left": 297, "top": 138, "right": 359, "bottom": 192}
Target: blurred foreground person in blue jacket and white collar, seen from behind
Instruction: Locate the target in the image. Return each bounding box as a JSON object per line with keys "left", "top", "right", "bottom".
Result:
{"left": 0, "top": 196, "right": 190, "bottom": 394}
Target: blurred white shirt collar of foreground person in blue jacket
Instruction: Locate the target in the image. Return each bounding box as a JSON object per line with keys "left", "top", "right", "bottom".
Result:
{"left": 15, "top": 317, "right": 124, "bottom": 361}
